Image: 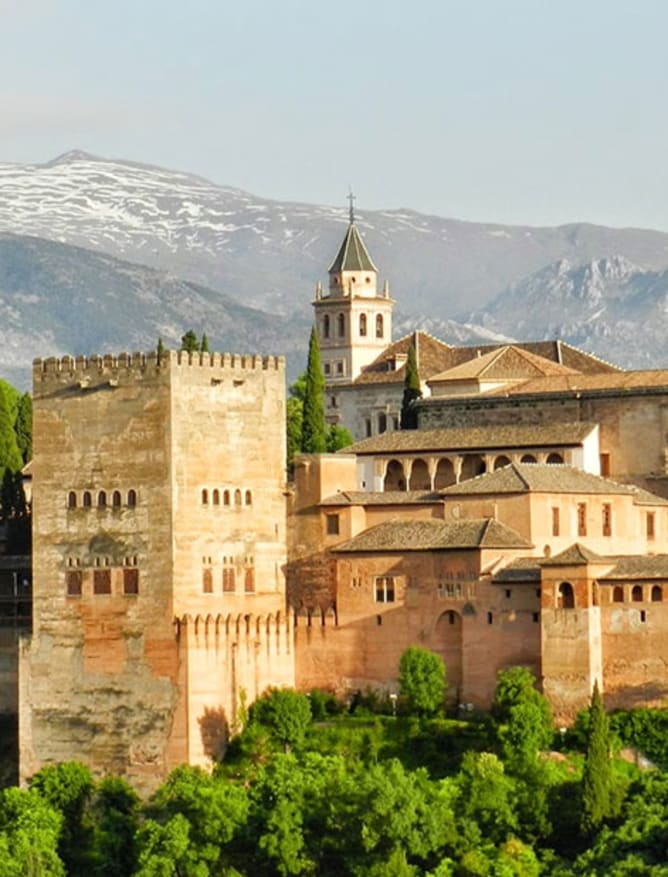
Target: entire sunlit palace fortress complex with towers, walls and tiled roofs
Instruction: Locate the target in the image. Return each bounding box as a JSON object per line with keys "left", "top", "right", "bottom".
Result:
{"left": 6, "top": 216, "right": 668, "bottom": 788}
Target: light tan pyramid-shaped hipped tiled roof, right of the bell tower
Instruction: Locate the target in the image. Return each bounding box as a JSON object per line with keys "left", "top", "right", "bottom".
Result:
{"left": 430, "top": 344, "right": 578, "bottom": 383}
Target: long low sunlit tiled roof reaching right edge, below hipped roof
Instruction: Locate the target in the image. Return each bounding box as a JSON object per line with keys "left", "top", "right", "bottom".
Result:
{"left": 485, "top": 369, "right": 668, "bottom": 396}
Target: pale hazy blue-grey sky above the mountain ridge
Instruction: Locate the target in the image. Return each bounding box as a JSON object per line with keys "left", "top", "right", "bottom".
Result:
{"left": 0, "top": 0, "right": 668, "bottom": 230}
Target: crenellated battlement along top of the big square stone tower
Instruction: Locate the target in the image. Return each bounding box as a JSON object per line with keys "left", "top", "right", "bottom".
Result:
{"left": 33, "top": 350, "right": 285, "bottom": 384}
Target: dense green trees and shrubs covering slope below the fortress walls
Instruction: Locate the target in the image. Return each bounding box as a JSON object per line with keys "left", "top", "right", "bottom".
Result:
{"left": 0, "top": 668, "right": 668, "bottom": 877}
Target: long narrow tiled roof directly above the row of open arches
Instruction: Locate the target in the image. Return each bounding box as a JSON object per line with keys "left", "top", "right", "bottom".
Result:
{"left": 341, "top": 423, "right": 596, "bottom": 454}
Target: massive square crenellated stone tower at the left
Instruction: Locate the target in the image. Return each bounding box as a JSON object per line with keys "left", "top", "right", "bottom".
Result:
{"left": 19, "top": 352, "right": 294, "bottom": 788}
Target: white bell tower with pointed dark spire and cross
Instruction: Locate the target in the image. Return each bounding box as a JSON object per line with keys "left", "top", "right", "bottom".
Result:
{"left": 313, "top": 198, "right": 394, "bottom": 389}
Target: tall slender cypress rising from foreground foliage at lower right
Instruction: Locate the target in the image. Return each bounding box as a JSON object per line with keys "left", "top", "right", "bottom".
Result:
{"left": 580, "top": 680, "right": 612, "bottom": 835}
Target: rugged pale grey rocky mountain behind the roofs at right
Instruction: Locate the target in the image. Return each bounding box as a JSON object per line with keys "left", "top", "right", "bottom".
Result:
{"left": 464, "top": 256, "right": 668, "bottom": 368}
